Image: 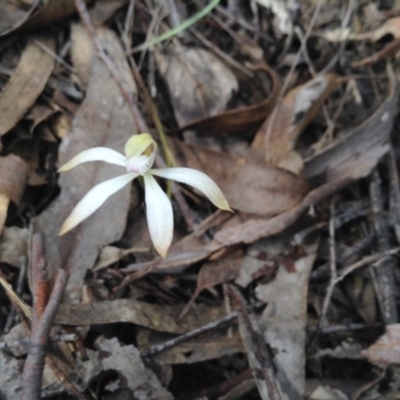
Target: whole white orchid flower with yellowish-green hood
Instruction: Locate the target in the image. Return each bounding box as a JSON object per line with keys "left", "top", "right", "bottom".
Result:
{"left": 59, "top": 133, "right": 232, "bottom": 258}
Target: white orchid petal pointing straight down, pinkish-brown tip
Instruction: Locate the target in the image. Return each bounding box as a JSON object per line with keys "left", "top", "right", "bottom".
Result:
{"left": 143, "top": 174, "right": 174, "bottom": 258}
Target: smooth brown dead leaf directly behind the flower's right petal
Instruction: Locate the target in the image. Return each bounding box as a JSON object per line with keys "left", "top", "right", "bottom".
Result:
{"left": 170, "top": 140, "right": 308, "bottom": 215}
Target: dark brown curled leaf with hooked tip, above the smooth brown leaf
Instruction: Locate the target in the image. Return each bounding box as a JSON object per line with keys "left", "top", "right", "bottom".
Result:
{"left": 178, "top": 64, "right": 281, "bottom": 136}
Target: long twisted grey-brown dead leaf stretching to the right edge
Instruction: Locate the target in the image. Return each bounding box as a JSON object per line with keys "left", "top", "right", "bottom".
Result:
{"left": 214, "top": 67, "right": 398, "bottom": 248}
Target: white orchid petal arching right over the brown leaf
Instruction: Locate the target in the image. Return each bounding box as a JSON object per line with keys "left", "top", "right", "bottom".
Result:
{"left": 149, "top": 168, "right": 232, "bottom": 211}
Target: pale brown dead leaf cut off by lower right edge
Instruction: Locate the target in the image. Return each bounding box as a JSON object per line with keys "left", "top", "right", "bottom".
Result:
{"left": 361, "top": 324, "right": 400, "bottom": 368}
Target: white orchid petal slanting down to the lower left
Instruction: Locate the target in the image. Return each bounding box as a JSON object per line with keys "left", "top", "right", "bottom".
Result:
{"left": 59, "top": 173, "right": 138, "bottom": 235}
